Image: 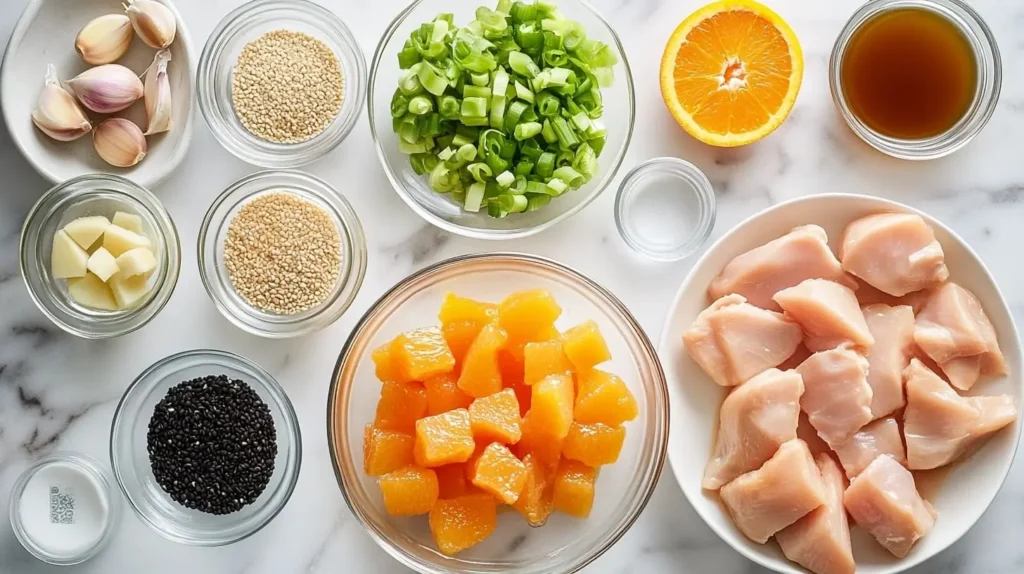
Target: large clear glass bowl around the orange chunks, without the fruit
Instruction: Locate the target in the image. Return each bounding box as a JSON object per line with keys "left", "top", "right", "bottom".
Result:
{"left": 328, "top": 254, "right": 669, "bottom": 574}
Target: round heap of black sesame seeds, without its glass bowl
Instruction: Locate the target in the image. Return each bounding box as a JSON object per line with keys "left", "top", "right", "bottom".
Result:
{"left": 146, "top": 374, "right": 278, "bottom": 515}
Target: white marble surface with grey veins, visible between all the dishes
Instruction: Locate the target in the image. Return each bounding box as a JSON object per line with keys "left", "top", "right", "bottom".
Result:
{"left": 0, "top": 0, "right": 1024, "bottom": 574}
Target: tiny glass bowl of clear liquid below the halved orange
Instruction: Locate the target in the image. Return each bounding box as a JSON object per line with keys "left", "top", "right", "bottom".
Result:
{"left": 615, "top": 158, "right": 715, "bottom": 261}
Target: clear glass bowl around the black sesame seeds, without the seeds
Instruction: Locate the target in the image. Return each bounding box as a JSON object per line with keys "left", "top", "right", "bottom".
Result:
{"left": 111, "top": 350, "right": 302, "bottom": 546}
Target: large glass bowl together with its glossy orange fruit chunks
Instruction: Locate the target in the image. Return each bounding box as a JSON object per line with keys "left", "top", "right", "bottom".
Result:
{"left": 328, "top": 254, "right": 668, "bottom": 574}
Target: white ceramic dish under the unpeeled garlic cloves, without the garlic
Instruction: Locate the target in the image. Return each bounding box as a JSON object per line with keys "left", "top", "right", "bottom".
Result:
{"left": 0, "top": 0, "right": 196, "bottom": 187}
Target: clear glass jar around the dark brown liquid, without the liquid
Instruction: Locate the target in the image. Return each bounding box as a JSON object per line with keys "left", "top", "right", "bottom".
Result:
{"left": 828, "top": 0, "right": 1002, "bottom": 160}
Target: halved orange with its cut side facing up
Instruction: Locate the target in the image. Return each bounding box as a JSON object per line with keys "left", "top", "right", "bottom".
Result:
{"left": 662, "top": 0, "right": 804, "bottom": 147}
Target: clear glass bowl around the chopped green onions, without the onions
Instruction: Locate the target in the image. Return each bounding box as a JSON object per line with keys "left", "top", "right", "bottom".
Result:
{"left": 368, "top": 0, "right": 636, "bottom": 239}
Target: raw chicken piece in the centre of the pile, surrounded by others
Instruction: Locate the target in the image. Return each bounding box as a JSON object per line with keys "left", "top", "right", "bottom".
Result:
{"left": 796, "top": 346, "right": 871, "bottom": 444}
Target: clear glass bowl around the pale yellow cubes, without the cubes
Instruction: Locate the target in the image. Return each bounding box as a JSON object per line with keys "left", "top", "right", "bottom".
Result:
{"left": 20, "top": 174, "right": 181, "bottom": 339}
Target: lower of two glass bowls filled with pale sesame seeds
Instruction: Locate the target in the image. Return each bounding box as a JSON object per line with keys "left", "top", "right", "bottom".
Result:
{"left": 198, "top": 171, "right": 367, "bottom": 339}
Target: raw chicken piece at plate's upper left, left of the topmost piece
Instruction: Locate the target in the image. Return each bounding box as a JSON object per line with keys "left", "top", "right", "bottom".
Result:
{"left": 708, "top": 225, "right": 856, "bottom": 311}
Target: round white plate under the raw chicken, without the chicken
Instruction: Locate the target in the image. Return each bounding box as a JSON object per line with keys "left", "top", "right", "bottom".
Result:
{"left": 658, "top": 194, "right": 1024, "bottom": 574}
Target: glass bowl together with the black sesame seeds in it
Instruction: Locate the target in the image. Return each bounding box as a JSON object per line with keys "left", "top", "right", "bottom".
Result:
{"left": 111, "top": 350, "right": 302, "bottom": 546}
